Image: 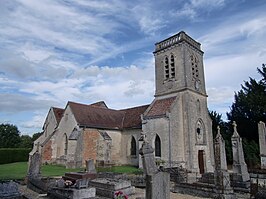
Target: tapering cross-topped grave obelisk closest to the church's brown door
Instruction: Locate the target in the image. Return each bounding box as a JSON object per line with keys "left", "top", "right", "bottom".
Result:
{"left": 214, "top": 126, "right": 235, "bottom": 199}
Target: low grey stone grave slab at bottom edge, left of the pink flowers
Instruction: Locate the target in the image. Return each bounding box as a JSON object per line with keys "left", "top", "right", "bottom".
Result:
{"left": 48, "top": 187, "right": 96, "bottom": 199}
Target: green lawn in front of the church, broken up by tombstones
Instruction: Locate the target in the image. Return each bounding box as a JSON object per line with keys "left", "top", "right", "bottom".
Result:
{"left": 0, "top": 162, "right": 142, "bottom": 180}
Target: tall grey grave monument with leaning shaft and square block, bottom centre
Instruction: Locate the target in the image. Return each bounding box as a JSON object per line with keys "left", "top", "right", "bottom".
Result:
{"left": 139, "top": 140, "right": 170, "bottom": 199}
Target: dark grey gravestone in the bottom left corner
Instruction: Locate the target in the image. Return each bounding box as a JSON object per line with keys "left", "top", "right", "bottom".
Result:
{"left": 0, "top": 181, "right": 22, "bottom": 199}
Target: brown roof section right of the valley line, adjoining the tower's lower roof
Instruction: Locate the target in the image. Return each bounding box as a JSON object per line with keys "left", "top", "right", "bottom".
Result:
{"left": 121, "top": 105, "right": 149, "bottom": 128}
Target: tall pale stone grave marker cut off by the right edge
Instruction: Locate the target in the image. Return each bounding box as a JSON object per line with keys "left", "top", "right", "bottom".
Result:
{"left": 258, "top": 121, "right": 266, "bottom": 169}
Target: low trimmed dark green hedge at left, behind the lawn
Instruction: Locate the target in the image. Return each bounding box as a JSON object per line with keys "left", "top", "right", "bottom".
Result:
{"left": 0, "top": 148, "right": 31, "bottom": 164}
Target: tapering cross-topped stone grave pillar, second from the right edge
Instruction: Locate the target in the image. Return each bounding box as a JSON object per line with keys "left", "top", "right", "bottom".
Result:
{"left": 231, "top": 121, "right": 250, "bottom": 185}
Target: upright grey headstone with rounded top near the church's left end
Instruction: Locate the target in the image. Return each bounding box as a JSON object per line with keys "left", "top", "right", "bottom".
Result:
{"left": 28, "top": 151, "right": 42, "bottom": 179}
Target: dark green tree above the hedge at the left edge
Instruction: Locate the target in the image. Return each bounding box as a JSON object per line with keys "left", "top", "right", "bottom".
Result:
{"left": 0, "top": 124, "right": 20, "bottom": 148}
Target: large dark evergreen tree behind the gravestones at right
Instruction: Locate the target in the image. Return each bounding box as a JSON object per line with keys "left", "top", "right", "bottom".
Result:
{"left": 227, "top": 64, "right": 266, "bottom": 140}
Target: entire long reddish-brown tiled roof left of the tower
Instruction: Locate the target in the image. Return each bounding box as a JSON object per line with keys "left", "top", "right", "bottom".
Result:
{"left": 68, "top": 102, "right": 149, "bottom": 130}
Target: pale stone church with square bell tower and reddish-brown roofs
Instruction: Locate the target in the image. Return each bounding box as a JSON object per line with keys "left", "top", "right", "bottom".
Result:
{"left": 31, "top": 32, "right": 214, "bottom": 173}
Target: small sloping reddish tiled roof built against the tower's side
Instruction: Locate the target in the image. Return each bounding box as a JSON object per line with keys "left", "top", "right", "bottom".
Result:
{"left": 145, "top": 97, "right": 176, "bottom": 117}
